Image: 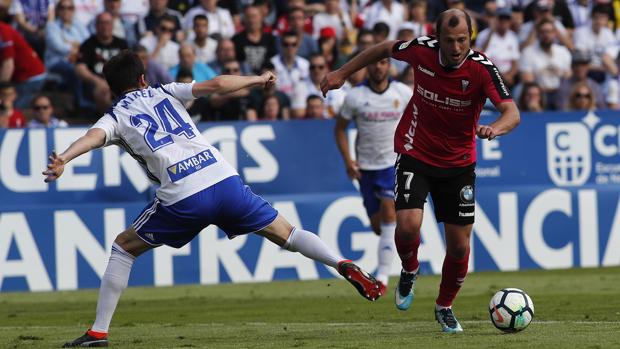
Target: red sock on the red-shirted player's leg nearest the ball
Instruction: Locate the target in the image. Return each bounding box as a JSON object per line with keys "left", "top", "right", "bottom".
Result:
{"left": 436, "top": 249, "right": 469, "bottom": 307}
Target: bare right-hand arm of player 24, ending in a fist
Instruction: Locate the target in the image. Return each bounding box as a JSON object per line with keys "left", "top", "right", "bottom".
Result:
{"left": 192, "top": 71, "right": 276, "bottom": 98}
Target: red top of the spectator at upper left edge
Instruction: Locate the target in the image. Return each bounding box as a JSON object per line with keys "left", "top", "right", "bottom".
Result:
{"left": 0, "top": 22, "right": 45, "bottom": 83}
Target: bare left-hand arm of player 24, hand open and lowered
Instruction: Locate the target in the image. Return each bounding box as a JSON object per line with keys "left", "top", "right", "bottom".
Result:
{"left": 43, "top": 128, "right": 106, "bottom": 183}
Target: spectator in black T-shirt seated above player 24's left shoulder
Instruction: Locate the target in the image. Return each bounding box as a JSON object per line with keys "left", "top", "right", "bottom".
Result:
{"left": 75, "top": 12, "right": 128, "bottom": 112}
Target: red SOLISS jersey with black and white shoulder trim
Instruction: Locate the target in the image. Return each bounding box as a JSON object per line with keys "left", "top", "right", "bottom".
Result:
{"left": 392, "top": 36, "right": 512, "bottom": 168}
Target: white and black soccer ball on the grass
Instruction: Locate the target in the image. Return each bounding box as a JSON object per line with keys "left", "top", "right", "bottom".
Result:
{"left": 489, "top": 288, "right": 534, "bottom": 333}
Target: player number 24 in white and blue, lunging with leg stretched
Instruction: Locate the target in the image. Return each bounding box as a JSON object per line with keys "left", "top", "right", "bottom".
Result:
{"left": 43, "top": 51, "right": 380, "bottom": 347}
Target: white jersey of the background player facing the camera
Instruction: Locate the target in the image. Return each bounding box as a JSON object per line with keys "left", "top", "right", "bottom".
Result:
{"left": 340, "top": 81, "right": 413, "bottom": 170}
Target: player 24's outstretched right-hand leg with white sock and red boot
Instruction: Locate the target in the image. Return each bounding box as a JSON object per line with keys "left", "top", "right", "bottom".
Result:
{"left": 257, "top": 215, "right": 381, "bottom": 301}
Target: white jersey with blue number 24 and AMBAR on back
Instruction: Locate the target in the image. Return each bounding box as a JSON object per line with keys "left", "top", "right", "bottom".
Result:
{"left": 92, "top": 83, "right": 237, "bottom": 205}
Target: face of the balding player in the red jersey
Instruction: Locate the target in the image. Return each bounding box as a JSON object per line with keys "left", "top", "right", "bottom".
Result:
{"left": 439, "top": 18, "right": 471, "bottom": 67}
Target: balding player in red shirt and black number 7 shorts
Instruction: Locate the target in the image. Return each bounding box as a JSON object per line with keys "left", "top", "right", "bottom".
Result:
{"left": 321, "top": 9, "right": 520, "bottom": 333}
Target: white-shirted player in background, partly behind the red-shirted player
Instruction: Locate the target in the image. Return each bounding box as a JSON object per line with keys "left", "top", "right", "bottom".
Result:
{"left": 334, "top": 59, "right": 413, "bottom": 294}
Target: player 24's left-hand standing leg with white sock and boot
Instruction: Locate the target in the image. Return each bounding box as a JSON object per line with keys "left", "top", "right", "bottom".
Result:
{"left": 63, "top": 228, "right": 152, "bottom": 348}
